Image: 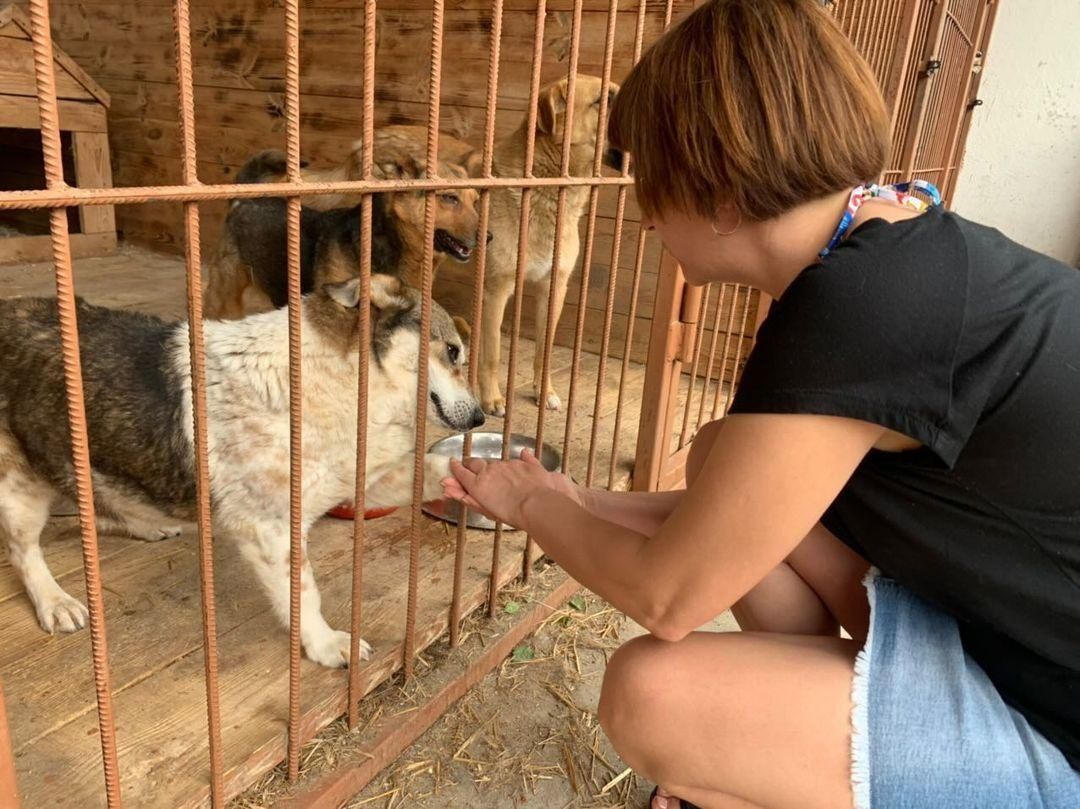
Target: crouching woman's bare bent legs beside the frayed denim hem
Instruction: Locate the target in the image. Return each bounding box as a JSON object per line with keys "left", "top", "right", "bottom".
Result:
{"left": 600, "top": 421, "right": 869, "bottom": 809}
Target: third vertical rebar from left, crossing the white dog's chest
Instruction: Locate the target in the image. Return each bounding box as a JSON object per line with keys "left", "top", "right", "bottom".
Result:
{"left": 285, "top": 0, "right": 305, "bottom": 781}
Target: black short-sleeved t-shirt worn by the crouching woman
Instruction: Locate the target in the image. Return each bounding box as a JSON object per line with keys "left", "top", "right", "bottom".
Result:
{"left": 731, "top": 210, "right": 1080, "bottom": 769}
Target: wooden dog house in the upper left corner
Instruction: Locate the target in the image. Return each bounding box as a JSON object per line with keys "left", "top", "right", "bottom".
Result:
{"left": 0, "top": 5, "right": 117, "bottom": 262}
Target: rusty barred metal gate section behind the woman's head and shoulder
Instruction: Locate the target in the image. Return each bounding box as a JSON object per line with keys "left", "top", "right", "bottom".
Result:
{"left": 634, "top": 0, "right": 997, "bottom": 490}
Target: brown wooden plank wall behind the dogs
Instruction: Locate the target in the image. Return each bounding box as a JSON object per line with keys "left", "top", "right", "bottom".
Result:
{"left": 21, "top": 0, "right": 690, "bottom": 359}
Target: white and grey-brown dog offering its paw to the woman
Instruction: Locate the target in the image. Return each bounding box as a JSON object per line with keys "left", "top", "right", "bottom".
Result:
{"left": 0, "top": 275, "right": 484, "bottom": 666}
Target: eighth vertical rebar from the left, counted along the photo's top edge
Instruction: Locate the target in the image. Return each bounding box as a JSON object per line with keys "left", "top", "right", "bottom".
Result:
{"left": 522, "top": 0, "right": 583, "bottom": 583}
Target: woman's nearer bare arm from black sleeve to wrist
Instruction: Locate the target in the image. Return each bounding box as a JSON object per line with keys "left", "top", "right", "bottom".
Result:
{"left": 516, "top": 415, "right": 883, "bottom": 641}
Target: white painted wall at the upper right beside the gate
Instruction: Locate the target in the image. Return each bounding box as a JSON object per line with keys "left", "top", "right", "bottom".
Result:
{"left": 953, "top": 0, "right": 1080, "bottom": 266}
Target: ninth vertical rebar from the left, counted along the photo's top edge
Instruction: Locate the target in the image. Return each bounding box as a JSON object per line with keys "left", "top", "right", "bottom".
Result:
{"left": 563, "top": 0, "right": 619, "bottom": 474}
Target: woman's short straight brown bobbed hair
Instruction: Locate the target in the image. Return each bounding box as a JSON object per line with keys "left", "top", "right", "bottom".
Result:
{"left": 608, "top": 0, "right": 889, "bottom": 220}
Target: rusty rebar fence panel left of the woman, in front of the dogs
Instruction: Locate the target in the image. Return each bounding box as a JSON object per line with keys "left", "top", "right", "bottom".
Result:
{"left": 0, "top": 0, "right": 678, "bottom": 808}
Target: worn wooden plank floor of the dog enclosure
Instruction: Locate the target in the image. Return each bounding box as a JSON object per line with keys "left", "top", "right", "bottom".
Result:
{"left": 0, "top": 246, "right": 644, "bottom": 809}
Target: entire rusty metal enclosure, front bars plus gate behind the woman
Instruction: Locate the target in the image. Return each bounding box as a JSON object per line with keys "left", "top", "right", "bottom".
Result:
{"left": 0, "top": 0, "right": 995, "bottom": 808}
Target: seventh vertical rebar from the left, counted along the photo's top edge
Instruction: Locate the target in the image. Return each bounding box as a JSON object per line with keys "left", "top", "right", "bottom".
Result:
{"left": 487, "top": 0, "right": 548, "bottom": 616}
